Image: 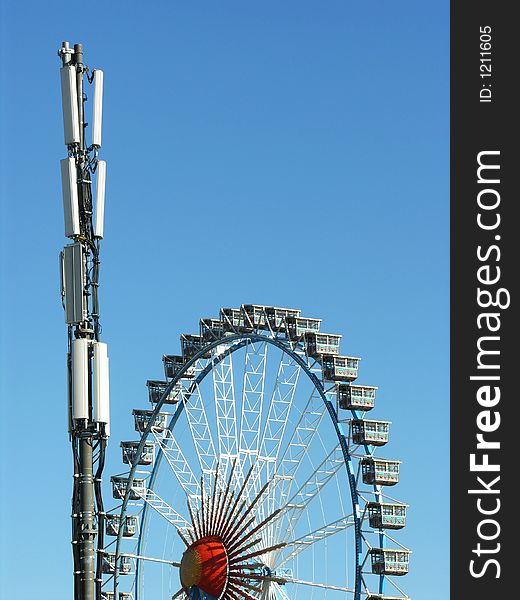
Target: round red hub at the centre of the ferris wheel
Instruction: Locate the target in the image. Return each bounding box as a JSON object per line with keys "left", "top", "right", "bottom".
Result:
{"left": 180, "top": 536, "right": 228, "bottom": 598}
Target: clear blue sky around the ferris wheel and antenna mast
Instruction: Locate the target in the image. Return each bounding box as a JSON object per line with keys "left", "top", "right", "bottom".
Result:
{"left": 0, "top": 0, "right": 449, "bottom": 600}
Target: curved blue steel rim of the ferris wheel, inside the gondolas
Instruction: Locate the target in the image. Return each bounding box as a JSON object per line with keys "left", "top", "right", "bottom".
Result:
{"left": 113, "top": 332, "right": 398, "bottom": 600}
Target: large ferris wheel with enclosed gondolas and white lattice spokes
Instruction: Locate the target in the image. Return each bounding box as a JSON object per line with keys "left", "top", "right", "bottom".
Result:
{"left": 100, "top": 304, "right": 410, "bottom": 600}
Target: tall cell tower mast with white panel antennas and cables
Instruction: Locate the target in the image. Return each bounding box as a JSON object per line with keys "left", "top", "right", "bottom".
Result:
{"left": 58, "top": 42, "right": 110, "bottom": 600}
